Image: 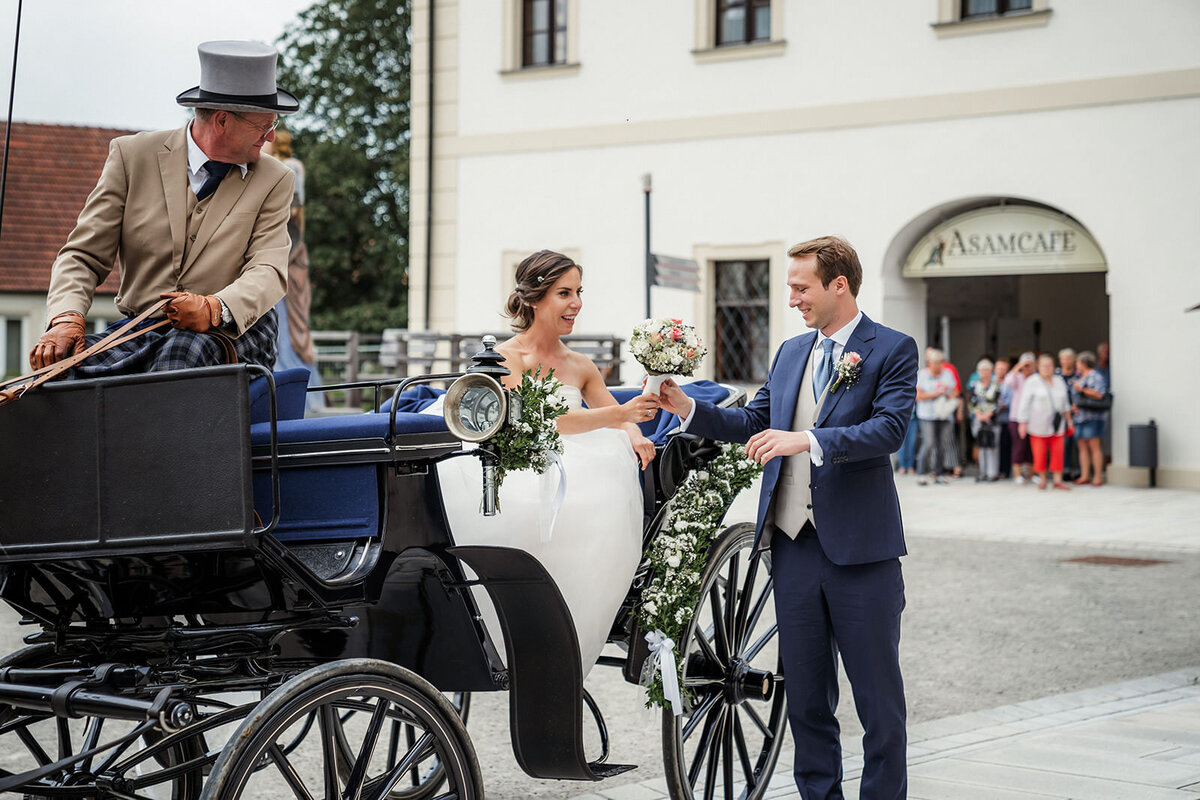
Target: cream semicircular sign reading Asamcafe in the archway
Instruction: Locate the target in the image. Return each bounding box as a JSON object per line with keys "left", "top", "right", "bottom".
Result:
{"left": 904, "top": 205, "right": 1108, "bottom": 278}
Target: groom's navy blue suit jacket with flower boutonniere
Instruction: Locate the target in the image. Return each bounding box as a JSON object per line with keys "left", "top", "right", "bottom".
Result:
{"left": 688, "top": 314, "right": 917, "bottom": 565}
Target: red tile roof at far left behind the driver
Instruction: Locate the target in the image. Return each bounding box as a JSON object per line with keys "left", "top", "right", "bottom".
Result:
{"left": 0, "top": 122, "right": 133, "bottom": 294}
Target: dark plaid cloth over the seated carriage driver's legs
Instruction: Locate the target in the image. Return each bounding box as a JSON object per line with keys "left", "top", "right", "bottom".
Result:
{"left": 71, "top": 308, "right": 278, "bottom": 379}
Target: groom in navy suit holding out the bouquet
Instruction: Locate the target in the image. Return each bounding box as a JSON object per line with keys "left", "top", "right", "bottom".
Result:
{"left": 660, "top": 236, "right": 917, "bottom": 800}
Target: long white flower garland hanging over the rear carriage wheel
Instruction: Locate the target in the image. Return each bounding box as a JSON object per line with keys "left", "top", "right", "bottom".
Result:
{"left": 637, "top": 444, "right": 762, "bottom": 708}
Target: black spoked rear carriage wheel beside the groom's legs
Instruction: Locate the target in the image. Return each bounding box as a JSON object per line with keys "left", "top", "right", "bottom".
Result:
{"left": 662, "top": 523, "right": 787, "bottom": 800}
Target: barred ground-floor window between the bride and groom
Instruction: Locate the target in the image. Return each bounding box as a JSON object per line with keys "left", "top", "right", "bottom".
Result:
{"left": 713, "top": 259, "right": 770, "bottom": 384}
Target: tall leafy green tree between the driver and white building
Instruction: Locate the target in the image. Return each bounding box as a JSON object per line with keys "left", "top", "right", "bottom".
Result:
{"left": 280, "top": 0, "right": 412, "bottom": 331}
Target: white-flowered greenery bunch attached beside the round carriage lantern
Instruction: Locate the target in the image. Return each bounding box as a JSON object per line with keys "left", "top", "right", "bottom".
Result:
{"left": 492, "top": 367, "right": 566, "bottom": 491}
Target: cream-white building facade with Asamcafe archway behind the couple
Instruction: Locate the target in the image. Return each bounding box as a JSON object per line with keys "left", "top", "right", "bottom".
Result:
{"left": 409, "top": 0, "right": 1200, "bottom": 488}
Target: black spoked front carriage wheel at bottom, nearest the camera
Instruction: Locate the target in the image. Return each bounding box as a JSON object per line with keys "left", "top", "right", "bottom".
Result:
{"left": 200, "top": 658, "right": 484, "bottom": 800}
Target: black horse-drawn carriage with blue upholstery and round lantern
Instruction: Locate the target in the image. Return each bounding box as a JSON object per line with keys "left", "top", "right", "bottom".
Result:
{"left": 0, "top": 347, "right": 786, "bottom": 800}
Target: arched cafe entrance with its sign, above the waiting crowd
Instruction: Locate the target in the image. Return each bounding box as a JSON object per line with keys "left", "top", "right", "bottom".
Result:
{"left": 883, "top": 197, "right": 1109, "bottom": 367}
